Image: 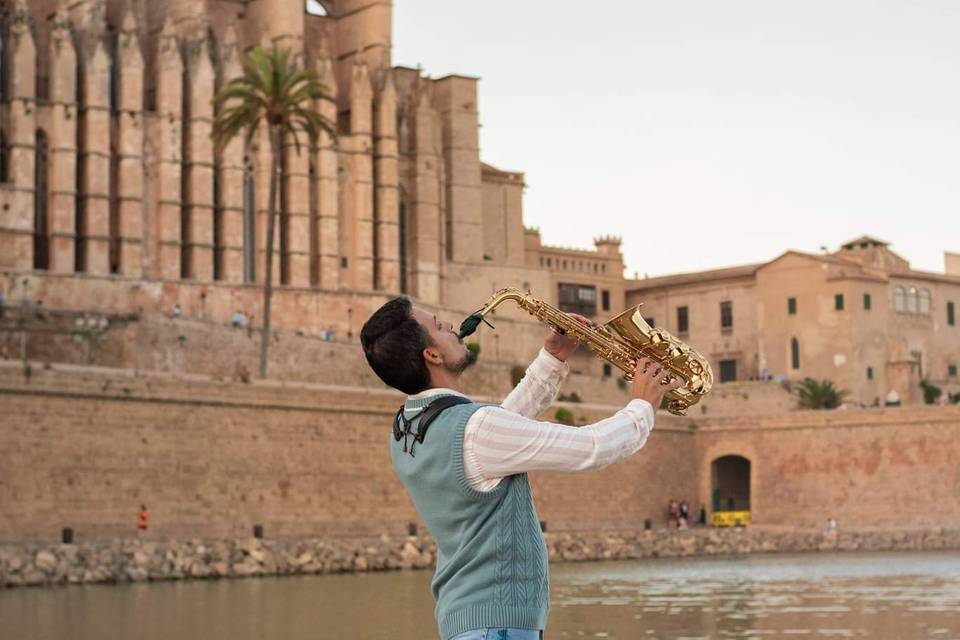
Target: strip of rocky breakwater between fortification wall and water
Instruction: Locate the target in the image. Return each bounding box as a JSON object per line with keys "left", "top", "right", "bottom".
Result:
{"left": 0, "top": 528, "right": 960, "bottom": 587}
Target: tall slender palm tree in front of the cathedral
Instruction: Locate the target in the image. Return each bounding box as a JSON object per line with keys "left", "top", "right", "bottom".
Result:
{"left": 213, "top": 45, "right": 336, "bottom": 378}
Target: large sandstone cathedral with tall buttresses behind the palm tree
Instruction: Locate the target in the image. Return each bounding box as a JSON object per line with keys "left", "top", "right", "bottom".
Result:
{"left": 0, "top": 0, "right": 624, "bottom": 338}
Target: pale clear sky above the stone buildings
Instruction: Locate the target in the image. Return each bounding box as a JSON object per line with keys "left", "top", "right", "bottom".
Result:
{"left": 393, "top": 0, "right": 960, "bottom": 277}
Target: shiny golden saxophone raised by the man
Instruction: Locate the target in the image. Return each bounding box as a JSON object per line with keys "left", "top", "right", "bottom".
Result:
{"left": 460, "top": 287, "right": 713, "bottom": 416}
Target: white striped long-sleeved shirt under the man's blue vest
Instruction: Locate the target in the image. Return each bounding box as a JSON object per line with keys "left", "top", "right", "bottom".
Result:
{"left": 402, "top": 349, "right": 654, "bottom": 491}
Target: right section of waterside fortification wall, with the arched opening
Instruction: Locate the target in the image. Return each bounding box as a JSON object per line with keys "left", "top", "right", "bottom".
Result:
{"left": 697, "top": 406, "right": 960, "bottom": 529}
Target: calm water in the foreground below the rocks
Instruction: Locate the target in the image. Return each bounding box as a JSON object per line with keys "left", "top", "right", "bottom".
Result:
{"left": 0, "top": 553, "right": 960, "bottom": 640}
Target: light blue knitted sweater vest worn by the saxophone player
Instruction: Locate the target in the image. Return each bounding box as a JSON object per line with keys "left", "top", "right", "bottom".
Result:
{"left": 390, "top": 395, "right": 550, "bottom": 640}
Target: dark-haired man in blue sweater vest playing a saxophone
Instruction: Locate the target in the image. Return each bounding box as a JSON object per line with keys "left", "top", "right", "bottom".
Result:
{"left": 360, "top": 296, "right": 681, "bottom": 640}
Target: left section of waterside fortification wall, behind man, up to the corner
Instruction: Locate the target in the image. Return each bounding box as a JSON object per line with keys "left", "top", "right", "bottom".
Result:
{"left": 0, "top": 363, "right": 695, "bottom": 541}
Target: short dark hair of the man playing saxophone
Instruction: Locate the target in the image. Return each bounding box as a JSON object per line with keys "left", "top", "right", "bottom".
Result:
{"left": 360, "top": 296, "right": 430, "bottom": 395}
